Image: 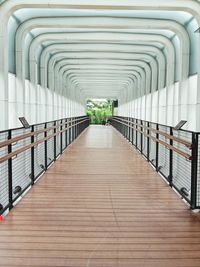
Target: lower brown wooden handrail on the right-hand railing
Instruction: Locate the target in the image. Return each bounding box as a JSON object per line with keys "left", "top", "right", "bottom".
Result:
{"left": 113, "top": 118, "right": 192, "bottom": 160}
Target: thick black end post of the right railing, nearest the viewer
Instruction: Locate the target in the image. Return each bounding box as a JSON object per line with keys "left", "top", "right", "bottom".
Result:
{"left": 191, "top": 133, "right": 198, "bottom": 209}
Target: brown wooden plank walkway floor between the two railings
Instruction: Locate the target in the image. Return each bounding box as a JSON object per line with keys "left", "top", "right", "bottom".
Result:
{"left": 0, "top": 126, "right": 200, "bottom": 267}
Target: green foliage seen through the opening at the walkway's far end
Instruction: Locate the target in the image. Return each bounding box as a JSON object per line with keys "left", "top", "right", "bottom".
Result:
{"left": 86, "top": 99, "right": 113, "bottom": 124}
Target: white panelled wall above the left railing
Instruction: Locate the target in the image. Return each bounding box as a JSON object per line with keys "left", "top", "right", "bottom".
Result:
{"left": 0, "top": 73, "right": 85, "bottom": 130}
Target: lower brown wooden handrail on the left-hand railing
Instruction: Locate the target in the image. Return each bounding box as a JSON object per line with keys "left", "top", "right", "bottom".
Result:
{"left": 0, "top": 118, "right": 89, "bottom": 164}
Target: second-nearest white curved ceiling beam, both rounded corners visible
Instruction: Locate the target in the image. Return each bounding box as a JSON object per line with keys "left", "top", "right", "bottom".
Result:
{"left": 16, "top": 17, "right": 190, "bottom": 78}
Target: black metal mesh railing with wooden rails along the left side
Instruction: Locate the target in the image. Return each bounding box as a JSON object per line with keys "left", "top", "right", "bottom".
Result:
{"left": 0, "top": 116, "right": 89, "bottom": 217}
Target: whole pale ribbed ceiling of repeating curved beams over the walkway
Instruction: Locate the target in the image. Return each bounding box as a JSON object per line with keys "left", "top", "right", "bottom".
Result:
{"left": 0, "top": 0, "right": 200, "bottom": 104}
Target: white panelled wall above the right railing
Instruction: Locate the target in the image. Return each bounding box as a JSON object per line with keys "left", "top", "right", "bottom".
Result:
{"left": 118, "top": 75, "right": 200, "bottom": 131}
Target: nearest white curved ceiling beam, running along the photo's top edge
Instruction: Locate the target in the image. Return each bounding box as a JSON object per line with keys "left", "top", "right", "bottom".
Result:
{"left": 0, "top": 0, "right": 200, "bottom": 105}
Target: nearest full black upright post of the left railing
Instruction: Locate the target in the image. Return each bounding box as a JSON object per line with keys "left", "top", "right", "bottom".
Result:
{"left": 8, "top": 130, "right": 13, "bottom": 210}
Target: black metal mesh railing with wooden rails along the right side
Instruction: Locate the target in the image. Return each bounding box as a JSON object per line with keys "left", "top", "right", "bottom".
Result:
{"left": 110, "top": 116, "right": 200, "bottom": 209}
